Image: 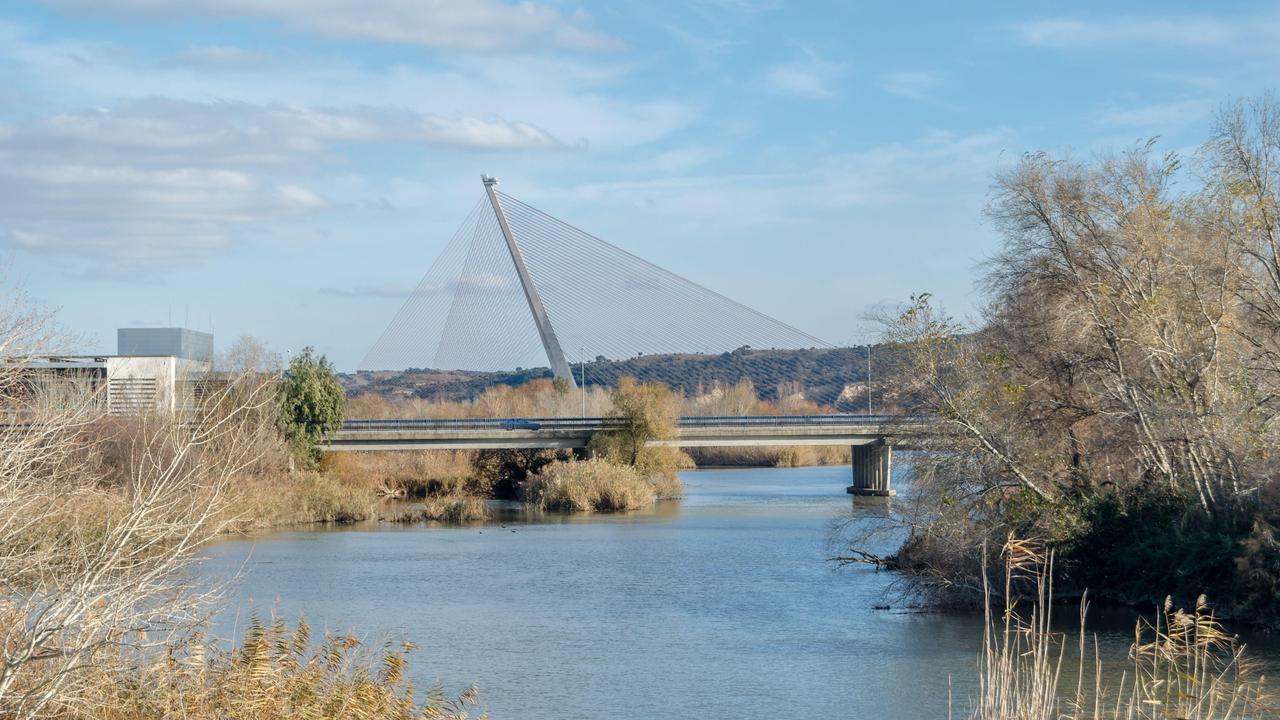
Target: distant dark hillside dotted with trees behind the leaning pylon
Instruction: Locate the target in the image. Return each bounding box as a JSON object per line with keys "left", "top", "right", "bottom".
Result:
{"left": 342, "top": 346, "right": 897, "bottom": 410}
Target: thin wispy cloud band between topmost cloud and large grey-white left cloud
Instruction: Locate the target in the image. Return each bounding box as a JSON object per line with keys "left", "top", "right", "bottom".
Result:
{"left": 0, "top": 23, "right": 700, "bottom": 149}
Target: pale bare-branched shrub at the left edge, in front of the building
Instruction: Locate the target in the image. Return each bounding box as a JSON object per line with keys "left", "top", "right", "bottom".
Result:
{"left": 0, "top": 289, "right": 279, "bottom": 717}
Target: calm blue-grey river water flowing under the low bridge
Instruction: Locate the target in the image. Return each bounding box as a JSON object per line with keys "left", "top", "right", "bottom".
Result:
{"left": 205, "top": 468, "right": 1280, "bottom": 720}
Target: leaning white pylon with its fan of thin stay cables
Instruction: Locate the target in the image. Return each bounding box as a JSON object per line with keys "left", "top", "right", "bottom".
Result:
{"left": 360, "top": 177, "right": 831, "bottom": 383}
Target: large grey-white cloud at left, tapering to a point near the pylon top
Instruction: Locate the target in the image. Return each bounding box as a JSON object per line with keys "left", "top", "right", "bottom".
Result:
{"left": 0, "top": 99, "right": 558, "bottom": 273}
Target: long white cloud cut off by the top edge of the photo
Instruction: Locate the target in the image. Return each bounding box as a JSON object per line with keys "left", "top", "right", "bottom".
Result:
{"left": 46, "top": 0, "right": 623, "bottom": 51}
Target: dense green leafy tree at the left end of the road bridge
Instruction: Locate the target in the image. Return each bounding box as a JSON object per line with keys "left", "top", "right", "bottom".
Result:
{"left": 280, "top": 347, "right": 346, "bottom": 460}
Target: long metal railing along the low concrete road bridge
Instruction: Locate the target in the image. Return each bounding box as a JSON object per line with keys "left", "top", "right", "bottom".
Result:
{"left": 342, "top": 415, "right": 925, "bottom": 432}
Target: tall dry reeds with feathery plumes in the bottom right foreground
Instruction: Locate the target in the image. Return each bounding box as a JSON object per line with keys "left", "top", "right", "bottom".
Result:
{"left": 970, "top": 538, "right": 1280, "bottom": 720}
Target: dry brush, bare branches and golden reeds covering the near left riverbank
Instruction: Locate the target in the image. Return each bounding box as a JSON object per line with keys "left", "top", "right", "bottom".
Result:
{"left": 0, "top": 299, "right": 494, "bottom": 720}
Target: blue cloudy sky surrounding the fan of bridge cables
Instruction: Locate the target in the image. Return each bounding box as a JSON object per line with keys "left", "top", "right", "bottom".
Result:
{"left": 0, "top": 0, "right": 1280, "bottom": 370}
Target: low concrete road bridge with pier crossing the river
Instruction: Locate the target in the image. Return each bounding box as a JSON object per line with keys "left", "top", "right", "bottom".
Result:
{"left": 321, "top": 415, "right": 924, "bottom": 496}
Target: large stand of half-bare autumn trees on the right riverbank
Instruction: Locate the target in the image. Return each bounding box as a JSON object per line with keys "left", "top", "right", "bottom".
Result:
{"left": 865, "top": 99, "right": 1280, "bottom": 624}
